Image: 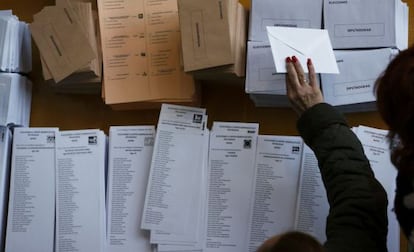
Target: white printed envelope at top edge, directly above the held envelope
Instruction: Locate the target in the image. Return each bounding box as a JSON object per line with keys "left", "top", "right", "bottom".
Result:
{"left": 249, "top": 0, "right": 322, "bottom": 41}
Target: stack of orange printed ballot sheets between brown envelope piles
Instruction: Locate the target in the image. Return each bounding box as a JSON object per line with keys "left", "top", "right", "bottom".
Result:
{"left": 98, "top": 0, "right": 199, "bottom": 109}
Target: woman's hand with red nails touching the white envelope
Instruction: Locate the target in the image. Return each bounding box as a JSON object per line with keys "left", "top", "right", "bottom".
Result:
{"left": 286, "top": 56, "right": 323, "bottom": 115}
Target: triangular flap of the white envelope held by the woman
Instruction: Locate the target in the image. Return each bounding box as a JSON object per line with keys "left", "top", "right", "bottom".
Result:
{"left": 267, "top": 26, "right": 325, "bottom": 55}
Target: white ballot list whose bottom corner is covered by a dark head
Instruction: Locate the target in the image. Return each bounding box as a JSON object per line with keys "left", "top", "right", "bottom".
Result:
{"left": 246, "top": 135, "right": 303, "bottom": 252}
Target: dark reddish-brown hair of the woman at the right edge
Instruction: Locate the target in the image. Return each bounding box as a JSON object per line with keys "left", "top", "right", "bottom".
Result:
{"left": 376, "top": 47, "right": 414, "bottom": 176}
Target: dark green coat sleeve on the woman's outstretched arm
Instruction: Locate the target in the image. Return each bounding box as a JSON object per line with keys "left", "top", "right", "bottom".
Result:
{"left": 298, "top": 103, "right": 388, "bottom": 252}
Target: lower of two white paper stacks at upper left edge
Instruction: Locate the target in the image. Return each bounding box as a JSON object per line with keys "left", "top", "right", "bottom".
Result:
{"left": 0, "top": 73, "right": 32, "bottom": 127}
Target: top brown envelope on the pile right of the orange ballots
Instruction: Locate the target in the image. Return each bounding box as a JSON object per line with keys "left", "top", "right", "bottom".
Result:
{"left": 178, "top": 0, "right": 236, "bottom": 72}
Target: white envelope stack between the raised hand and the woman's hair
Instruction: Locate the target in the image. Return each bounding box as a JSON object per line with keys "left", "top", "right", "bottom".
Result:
{"left": 321, "top": 48, "right": 398, "bottom": 112}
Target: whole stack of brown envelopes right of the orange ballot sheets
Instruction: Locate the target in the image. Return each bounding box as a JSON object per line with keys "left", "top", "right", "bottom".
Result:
{"left": 178, "top": 0, "right": 247, "bottom": 79}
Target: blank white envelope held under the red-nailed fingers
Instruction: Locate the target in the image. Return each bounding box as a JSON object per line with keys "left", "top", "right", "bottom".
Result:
{"left": 267, "top": 26, "right": 339, "bottom": 74}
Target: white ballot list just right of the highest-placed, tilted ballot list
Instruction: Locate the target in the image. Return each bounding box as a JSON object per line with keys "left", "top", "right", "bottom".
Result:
{"left": 203, "top": 122, "right": 259, "bottom": 252}
